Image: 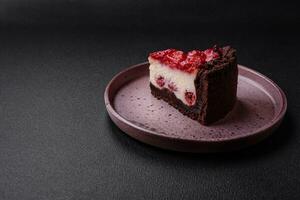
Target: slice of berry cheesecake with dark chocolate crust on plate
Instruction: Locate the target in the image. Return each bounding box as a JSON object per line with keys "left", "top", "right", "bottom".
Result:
{"left": 148, "top": 46, "right": 238, "bottom": 125}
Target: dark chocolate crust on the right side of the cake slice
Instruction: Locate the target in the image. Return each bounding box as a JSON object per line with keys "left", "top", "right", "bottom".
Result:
{"left": 195, "top": 47, "right": 238, "bottom": 125}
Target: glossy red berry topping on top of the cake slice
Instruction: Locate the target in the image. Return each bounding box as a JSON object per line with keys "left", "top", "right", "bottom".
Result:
{"left": 149, "top": 46, "right": 222, "bottom": 73}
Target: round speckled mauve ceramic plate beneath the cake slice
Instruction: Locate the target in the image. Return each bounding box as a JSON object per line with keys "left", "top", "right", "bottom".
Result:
{"left": 104, "top": 63, "right": 287, "bottom": 152}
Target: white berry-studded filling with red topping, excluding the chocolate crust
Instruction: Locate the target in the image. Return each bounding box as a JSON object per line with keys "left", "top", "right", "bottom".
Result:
{"left": 148, "top": 48, "right": 220, "bottom": 106}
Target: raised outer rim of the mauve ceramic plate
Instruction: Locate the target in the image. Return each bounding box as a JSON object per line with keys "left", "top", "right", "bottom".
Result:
{"left": 104, "top": 62, "right": 287, "bottom": 148}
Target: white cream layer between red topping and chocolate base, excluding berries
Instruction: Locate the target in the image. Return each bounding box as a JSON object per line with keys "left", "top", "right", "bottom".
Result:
{"left": 148, "top": 57, "right": 197, "bottom": 105}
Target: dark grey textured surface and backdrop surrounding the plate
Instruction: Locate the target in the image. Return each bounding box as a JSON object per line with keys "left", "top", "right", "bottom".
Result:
{"left": 0, "top": 0, "right": 300, "bottom": 200}
